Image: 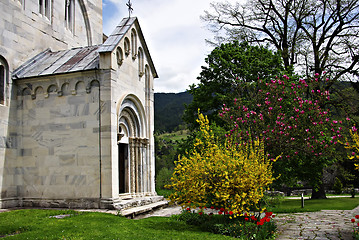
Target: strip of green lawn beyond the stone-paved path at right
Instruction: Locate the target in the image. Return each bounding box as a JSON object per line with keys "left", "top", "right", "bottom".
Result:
{"left": 269, "top": 197, "right": 359, "bottom": 213}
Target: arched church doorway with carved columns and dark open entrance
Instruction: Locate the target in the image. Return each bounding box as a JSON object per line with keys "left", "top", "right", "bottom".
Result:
{"left": 117, "top": 95, "right": 150, "bottom": 196}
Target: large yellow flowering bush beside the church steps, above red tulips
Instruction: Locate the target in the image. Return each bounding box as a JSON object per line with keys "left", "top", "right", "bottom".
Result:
{"left": 168, "top": 114, "right": 274, "bottom": 216}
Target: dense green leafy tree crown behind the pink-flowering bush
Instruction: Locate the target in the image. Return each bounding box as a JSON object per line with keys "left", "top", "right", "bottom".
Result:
{"left": 183, "top": 42, "right": 284, "bottom": 128}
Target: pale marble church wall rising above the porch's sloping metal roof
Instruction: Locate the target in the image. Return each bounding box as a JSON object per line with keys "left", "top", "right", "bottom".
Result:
{"left": 0, "top": 0, "right": 103, "bottom": 71}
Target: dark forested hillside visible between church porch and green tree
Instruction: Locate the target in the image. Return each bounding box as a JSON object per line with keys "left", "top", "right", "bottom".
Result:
{"left": 155, "top": 92, "right": 193, "bottom": 132}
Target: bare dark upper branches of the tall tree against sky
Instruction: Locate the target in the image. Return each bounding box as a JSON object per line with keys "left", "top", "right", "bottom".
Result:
{"left": 202, "top": 0, "right": 359, "bottom": 83}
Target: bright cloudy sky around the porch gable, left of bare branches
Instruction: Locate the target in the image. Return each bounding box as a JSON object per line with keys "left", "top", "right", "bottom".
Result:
{"left": 103, "top": 0, "right": 239, "bottom": 93}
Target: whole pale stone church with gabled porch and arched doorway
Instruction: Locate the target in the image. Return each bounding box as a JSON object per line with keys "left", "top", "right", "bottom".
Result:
{"left": 0, "top": 0, "right": 158, "bottom": 209}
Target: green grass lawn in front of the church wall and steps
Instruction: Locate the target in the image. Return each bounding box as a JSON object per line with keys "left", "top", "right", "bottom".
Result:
{"left": 0, "top": 209, "right": 232, "bottom": 240}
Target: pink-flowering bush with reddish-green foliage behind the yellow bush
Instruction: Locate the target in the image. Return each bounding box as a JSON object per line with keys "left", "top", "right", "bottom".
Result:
{"left": 220, "top": 75, "right": 350, "bottom": 187}
